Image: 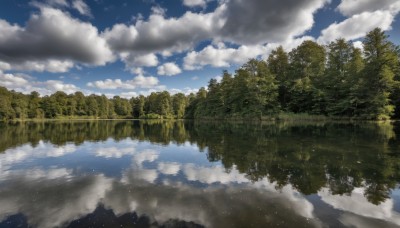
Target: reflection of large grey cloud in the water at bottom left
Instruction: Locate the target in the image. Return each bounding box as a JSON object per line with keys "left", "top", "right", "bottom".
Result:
{"left": 0, "top": 173, "right": 112, "bottom": 228}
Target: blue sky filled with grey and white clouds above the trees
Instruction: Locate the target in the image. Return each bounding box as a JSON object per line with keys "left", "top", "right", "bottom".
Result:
{"left": 0, "top": 0, "right": 400, "bottom": 98}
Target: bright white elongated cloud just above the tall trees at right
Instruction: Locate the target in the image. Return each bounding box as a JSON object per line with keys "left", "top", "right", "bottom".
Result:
{"left": 318, "top": 10, "right": 394, "bottom": 43}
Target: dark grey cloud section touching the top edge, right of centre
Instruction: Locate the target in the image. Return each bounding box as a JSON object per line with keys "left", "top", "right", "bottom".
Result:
{"left": 220, "top": 0, "right": 330, "bottom": 45}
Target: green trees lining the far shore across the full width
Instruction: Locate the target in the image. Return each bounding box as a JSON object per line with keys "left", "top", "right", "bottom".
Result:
{"left": 0, "top": 28, "right": 400, "bottom": 120}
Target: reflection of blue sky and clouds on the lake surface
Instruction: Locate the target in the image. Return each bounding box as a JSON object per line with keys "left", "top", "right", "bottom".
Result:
{"left": 0, "top": 139, "right": 400, "bottom": 227}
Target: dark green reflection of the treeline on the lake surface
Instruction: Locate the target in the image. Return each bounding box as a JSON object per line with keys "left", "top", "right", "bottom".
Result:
{"left": 0, "top": 120, "right": 400, "bottom": 205}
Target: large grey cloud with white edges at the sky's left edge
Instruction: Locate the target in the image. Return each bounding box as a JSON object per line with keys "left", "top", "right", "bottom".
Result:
{"left": 0, "top": 6, "right": 114, "bottom": 72}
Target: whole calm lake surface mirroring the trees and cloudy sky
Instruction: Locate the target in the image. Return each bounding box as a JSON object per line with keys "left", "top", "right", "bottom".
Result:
{"left": 0, "top": 121, "right": 400, "bottom": 228}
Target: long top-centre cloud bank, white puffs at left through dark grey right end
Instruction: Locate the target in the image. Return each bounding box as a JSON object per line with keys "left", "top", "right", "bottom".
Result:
{"left": 103, "top": 0, "right": 329, "bottom": 56}
